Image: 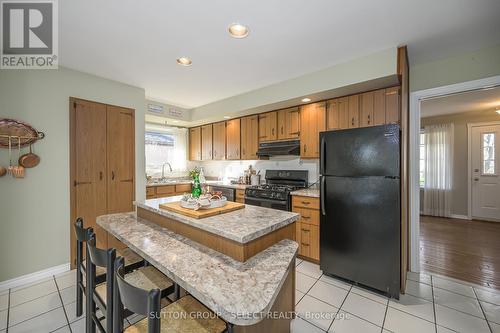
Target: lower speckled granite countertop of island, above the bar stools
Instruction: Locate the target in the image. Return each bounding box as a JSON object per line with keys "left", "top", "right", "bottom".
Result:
{"left": 97, "top": 212, "right": 298, "bottom": 325}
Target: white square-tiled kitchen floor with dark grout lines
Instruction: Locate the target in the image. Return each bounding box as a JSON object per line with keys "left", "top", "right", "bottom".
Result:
{"left": 0, "top": 259, "right": 500, "bottom": 333}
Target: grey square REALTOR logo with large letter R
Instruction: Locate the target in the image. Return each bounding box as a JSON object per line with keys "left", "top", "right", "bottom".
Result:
{"left": 0, "top": 0, "right": 58, "bottom": 69}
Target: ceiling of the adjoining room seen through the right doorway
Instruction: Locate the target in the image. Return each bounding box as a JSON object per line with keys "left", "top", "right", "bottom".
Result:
{"left": 420, "top": 87, "right": 500, "bottom": 117}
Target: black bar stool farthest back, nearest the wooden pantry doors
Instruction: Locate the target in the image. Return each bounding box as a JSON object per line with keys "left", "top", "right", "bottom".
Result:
{"left": 74, "top": 217, "right": 145, "bottom": 317}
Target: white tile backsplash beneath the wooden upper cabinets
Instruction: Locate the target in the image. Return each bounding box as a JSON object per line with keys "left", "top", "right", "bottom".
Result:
{"left": 188, "top": 156, "right": 319, "bottom": 184}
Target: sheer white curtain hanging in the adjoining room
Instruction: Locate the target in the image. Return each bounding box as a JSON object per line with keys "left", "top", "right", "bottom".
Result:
{"left": 424, "top": 124, "right": 453, "bottom": 217}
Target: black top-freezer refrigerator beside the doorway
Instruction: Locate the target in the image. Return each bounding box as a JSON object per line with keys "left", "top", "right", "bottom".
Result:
{"left": 320, "top": 125, "right": 401, "bottom": 299}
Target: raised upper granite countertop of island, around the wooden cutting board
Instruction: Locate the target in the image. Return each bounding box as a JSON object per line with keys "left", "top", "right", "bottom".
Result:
{"left": 135, "top": 196, "right": 300, "bottom": 244}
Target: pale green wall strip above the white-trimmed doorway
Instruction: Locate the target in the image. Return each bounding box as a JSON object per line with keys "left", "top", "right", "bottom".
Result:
{"left": 410, "top": 45, "right": 500, "bottom": 91}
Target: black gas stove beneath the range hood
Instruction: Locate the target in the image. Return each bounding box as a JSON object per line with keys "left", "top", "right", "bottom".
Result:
{"left": 245, "top": 170, "right": 308, "bottom": 210}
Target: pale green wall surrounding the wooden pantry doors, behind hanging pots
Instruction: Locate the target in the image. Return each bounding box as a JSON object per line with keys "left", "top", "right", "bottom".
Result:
{"left": 0, "top": 68, "right": 145, "bottom": 281}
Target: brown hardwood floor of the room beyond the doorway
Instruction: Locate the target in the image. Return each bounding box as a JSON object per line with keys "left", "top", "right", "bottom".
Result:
{"left": 420, "top": 216, "right": 500, "bottom": 289}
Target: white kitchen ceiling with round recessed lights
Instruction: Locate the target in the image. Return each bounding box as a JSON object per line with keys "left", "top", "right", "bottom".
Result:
{"left": 59, "top": 0, "right": 500, "bottom": 108}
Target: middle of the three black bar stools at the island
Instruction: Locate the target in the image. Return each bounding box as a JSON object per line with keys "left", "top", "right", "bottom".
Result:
{"left": 86, "top": 234, "right": 175, "bottom": 333}
